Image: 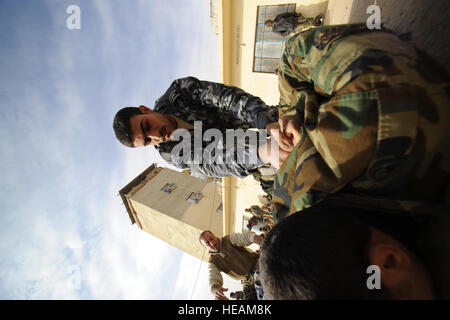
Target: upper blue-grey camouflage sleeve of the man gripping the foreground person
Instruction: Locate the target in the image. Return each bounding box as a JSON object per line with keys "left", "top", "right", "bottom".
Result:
{"left": 164, "top": 77, "right": 278, "bottom": 129}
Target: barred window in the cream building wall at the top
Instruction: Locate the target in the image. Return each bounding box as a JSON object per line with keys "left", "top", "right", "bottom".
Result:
{"left": 253, "top": 4, "right": 295, "bottom": 73}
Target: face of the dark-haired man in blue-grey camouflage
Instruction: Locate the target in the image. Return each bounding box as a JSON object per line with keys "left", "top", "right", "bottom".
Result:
{"left": 130, "top": 106, "right": 177, "bottom": 147}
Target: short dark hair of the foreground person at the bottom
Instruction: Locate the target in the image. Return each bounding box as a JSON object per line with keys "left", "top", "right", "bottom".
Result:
{"left": 259, "top": 203, "right": 388, "bottom": 300}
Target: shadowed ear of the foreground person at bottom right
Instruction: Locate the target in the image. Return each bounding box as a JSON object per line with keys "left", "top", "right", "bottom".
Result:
{"left": 368, "top": 243, "right": 411, "bottom": 288}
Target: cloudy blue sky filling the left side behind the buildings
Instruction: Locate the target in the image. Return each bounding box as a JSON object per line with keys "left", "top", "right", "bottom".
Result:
{"left": 0, "top": 0, "right": 239, "bottom": 299}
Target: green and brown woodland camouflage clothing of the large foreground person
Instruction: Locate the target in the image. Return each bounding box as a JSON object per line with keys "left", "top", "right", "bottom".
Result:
{"left": 273, "top": 25, "right": 450, "bottom": 220}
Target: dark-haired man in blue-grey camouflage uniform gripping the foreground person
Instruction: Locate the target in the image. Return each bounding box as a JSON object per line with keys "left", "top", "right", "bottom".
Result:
{"left": 113, "top": 77, "right": 278, "bottom": 179}
